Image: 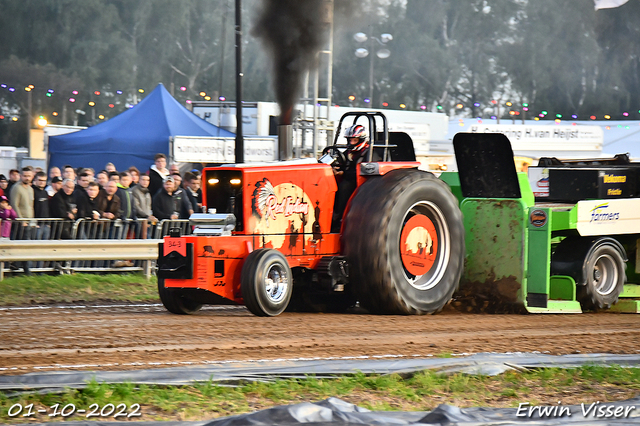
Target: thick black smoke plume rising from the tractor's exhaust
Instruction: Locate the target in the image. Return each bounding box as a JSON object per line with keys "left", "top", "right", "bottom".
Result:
{"left": 253, "top": 0, "right": 328, "bottom": 124}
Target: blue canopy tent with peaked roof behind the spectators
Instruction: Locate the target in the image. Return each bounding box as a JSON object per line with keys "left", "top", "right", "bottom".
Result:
{"left": 49, "top": 84, "right": 235, "bottom": 172}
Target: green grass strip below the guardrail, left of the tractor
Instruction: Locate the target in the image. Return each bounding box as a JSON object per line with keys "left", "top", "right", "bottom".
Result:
{"left": 0, "top": 274, "right": 158, "bottom": 306}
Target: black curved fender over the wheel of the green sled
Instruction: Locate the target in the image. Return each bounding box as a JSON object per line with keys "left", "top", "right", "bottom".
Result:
{"left": 551, "top": 237, "right": 628, "bottom": 286}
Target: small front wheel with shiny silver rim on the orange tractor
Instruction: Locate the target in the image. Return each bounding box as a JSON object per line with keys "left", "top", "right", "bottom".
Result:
{"left": 240, "top": 249, "right": 293, "bottom": 317}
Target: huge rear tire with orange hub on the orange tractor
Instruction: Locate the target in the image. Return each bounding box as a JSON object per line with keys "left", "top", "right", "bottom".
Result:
{"left": 342, "top": 169, "right": 465, "bottom": 315}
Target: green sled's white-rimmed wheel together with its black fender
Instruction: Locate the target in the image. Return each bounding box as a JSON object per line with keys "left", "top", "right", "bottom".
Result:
{"left": 551, "top": 237, "right": 626, "bottom": 310}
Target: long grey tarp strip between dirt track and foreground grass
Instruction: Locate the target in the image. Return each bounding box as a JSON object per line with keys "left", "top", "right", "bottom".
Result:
{"left": 0, "top": 353, "right": 640, "bottom": 391}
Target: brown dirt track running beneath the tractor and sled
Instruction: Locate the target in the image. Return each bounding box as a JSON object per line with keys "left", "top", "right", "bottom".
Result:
{"left": 0, "top": 304, "right": 640, "bottom": 374}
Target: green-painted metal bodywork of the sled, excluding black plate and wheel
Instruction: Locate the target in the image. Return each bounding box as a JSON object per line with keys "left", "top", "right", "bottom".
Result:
{"left": 440, "top": 172, "right": 640, "bottom": 313}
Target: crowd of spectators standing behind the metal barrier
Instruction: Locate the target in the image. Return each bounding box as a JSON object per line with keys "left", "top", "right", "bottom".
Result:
{"left": 0, "top": 154, "right": 202, "bottom": 239}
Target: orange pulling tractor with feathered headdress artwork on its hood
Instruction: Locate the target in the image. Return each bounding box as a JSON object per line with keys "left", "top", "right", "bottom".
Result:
{"left": 158, "top": 112, "right": 465, "bottom": 316}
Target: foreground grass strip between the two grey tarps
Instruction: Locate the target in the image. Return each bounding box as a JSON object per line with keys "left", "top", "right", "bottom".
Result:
{"left": 0, "top": 366, "right": 640, "bottom": 424}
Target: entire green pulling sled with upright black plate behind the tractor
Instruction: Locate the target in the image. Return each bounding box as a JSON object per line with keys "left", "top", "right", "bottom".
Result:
{"left": 440, "top": 133, "right": 640, "bottom": 313}
